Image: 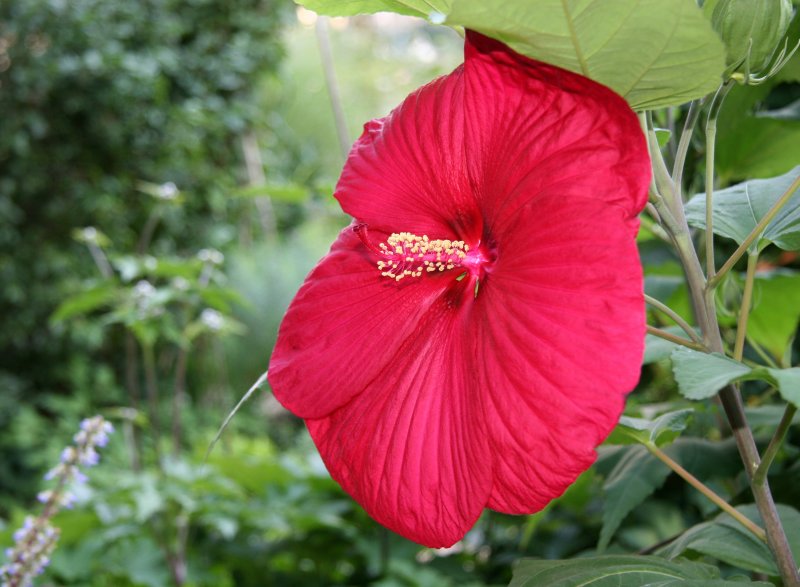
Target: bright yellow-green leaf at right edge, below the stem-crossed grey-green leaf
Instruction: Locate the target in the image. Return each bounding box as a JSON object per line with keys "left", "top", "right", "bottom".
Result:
{"left": 747, "top": 272, "right": 800, "bottom": 359}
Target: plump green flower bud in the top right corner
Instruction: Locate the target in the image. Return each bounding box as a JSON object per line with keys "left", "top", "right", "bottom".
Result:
{"left": 711, "top": 0, "right": 792, "bottom": 77}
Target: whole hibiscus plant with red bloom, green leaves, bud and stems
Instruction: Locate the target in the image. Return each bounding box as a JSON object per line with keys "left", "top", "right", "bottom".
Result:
{"left": 268, "top": 0, "right": 800, "bottom": 586}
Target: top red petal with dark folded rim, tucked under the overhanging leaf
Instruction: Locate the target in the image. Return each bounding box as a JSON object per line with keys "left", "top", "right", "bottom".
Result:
{"left": 464, "top": 32, "right": 650, "bottom": 234}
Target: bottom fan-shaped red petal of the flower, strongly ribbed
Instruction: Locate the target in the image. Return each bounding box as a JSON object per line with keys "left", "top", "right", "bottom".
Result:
{"left": 306, "top": 300, "right": 492, "bottom": 547}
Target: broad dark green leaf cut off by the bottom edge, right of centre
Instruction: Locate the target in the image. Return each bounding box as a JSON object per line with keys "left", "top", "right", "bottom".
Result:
{"left": 509, "top": 555, "right": 719, "bottom": 587}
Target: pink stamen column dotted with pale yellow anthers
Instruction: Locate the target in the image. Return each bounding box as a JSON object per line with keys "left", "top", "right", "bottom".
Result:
{"left": 353, "top": 224, "right": 490, "bottom": 281}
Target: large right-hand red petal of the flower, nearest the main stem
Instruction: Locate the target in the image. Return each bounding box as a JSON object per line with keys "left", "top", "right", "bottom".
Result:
{"left": 468, "top": 194, "right": 645, "bottom": 513}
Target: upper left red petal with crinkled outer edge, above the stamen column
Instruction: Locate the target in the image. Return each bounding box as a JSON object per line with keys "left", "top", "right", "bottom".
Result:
{"left": 334, "top": 61, "right": 483, "bottom": 242}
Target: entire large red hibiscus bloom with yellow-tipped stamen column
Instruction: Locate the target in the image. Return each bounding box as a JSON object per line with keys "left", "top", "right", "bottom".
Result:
{"left": 269, "top": 32, "right": 650, "bottom": 547}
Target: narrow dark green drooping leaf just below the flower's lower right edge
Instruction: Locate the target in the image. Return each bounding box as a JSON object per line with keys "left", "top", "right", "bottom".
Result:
{"left": 597, "top": 445, "right": 670, "bottom": 551}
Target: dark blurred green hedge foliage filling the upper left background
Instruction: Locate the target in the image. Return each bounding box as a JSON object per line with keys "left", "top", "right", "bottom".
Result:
{"left": 0, "top": 0, "right": 287, "bottom": 507}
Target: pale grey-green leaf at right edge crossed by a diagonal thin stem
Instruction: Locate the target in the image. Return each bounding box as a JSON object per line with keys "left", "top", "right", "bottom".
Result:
{"left": 686, "top": 166, "right": 800, "bottom": 253}
